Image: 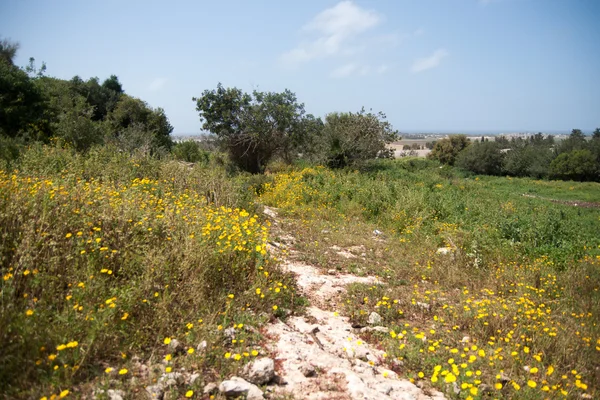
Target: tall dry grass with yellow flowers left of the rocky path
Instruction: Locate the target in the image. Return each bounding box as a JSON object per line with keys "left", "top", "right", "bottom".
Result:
{"left": 0, "top": 145, "right": 299, "bottom": 398}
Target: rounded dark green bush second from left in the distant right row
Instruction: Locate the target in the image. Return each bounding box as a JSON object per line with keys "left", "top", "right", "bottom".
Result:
{"left": 456, "top": 141, "right": 504, "bottom": 175}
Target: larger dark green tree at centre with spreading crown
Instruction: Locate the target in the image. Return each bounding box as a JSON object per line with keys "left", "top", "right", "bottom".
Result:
{"left": 193, "top": 83, "right": 306, "bottom": 173}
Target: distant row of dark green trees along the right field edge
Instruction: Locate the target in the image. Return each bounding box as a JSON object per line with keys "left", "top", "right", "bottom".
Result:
{"left": 428, "top": 128, "right": 600, "bottom": 182}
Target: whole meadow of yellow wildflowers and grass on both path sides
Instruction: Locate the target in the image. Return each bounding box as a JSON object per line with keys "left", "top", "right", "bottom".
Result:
{"left": 0, "top": 145, "right": 600, "bottom": 399}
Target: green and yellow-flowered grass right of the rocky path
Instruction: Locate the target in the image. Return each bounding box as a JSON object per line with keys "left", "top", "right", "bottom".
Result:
{"left": 261, "top": 160, "right": 600, "bottom": 399}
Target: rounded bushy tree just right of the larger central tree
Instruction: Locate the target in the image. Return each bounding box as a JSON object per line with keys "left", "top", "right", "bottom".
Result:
{"left": 321, "top": 108, "right": 398, "bottom": 168}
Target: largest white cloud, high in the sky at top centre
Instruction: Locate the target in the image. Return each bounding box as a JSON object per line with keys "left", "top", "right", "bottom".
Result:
{"left": 281, "top": 1, "right": 382, "bottom": 66}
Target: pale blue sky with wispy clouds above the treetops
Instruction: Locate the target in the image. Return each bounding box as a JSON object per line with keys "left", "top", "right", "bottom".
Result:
{"left": 0, "top": 0, "right": 600, "bottom": 134}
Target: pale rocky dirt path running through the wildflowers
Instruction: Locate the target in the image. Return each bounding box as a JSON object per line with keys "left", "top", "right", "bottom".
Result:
{"left": 265, "top": 208, "right": 444, "bottom": 400}
